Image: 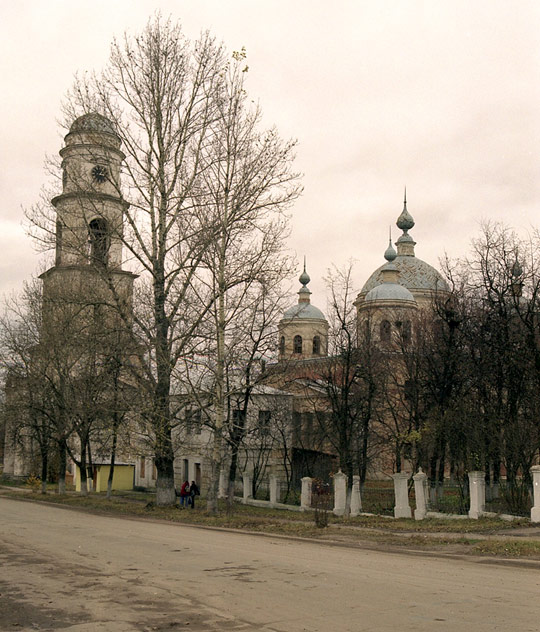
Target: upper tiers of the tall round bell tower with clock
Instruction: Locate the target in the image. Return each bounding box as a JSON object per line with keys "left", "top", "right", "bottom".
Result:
{"left": 40, "top": 112, "right": 136, "bottom": 328}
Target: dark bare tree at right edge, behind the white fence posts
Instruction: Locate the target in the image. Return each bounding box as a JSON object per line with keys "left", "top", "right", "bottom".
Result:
{"left": 458, "top": 224, "right": 540, "bottom": 511}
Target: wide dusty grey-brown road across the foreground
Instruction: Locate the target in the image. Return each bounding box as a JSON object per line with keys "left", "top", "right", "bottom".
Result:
{"left": 0, "top": 498, "right": 540, "bottom": 632}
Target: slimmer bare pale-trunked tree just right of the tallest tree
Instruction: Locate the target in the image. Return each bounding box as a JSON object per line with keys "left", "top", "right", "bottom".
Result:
{"left": 177, "top": 51, "right": 300, "bottom": 511}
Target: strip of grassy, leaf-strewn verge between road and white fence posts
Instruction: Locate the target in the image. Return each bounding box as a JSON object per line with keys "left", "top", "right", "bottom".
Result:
{"left": 4, "top": 486, "right": 540, "bottom": 567}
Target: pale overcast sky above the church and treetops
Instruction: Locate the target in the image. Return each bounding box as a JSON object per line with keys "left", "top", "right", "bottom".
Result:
{"left": 0, "top": 0, "right": 540, "bottom": 309}
